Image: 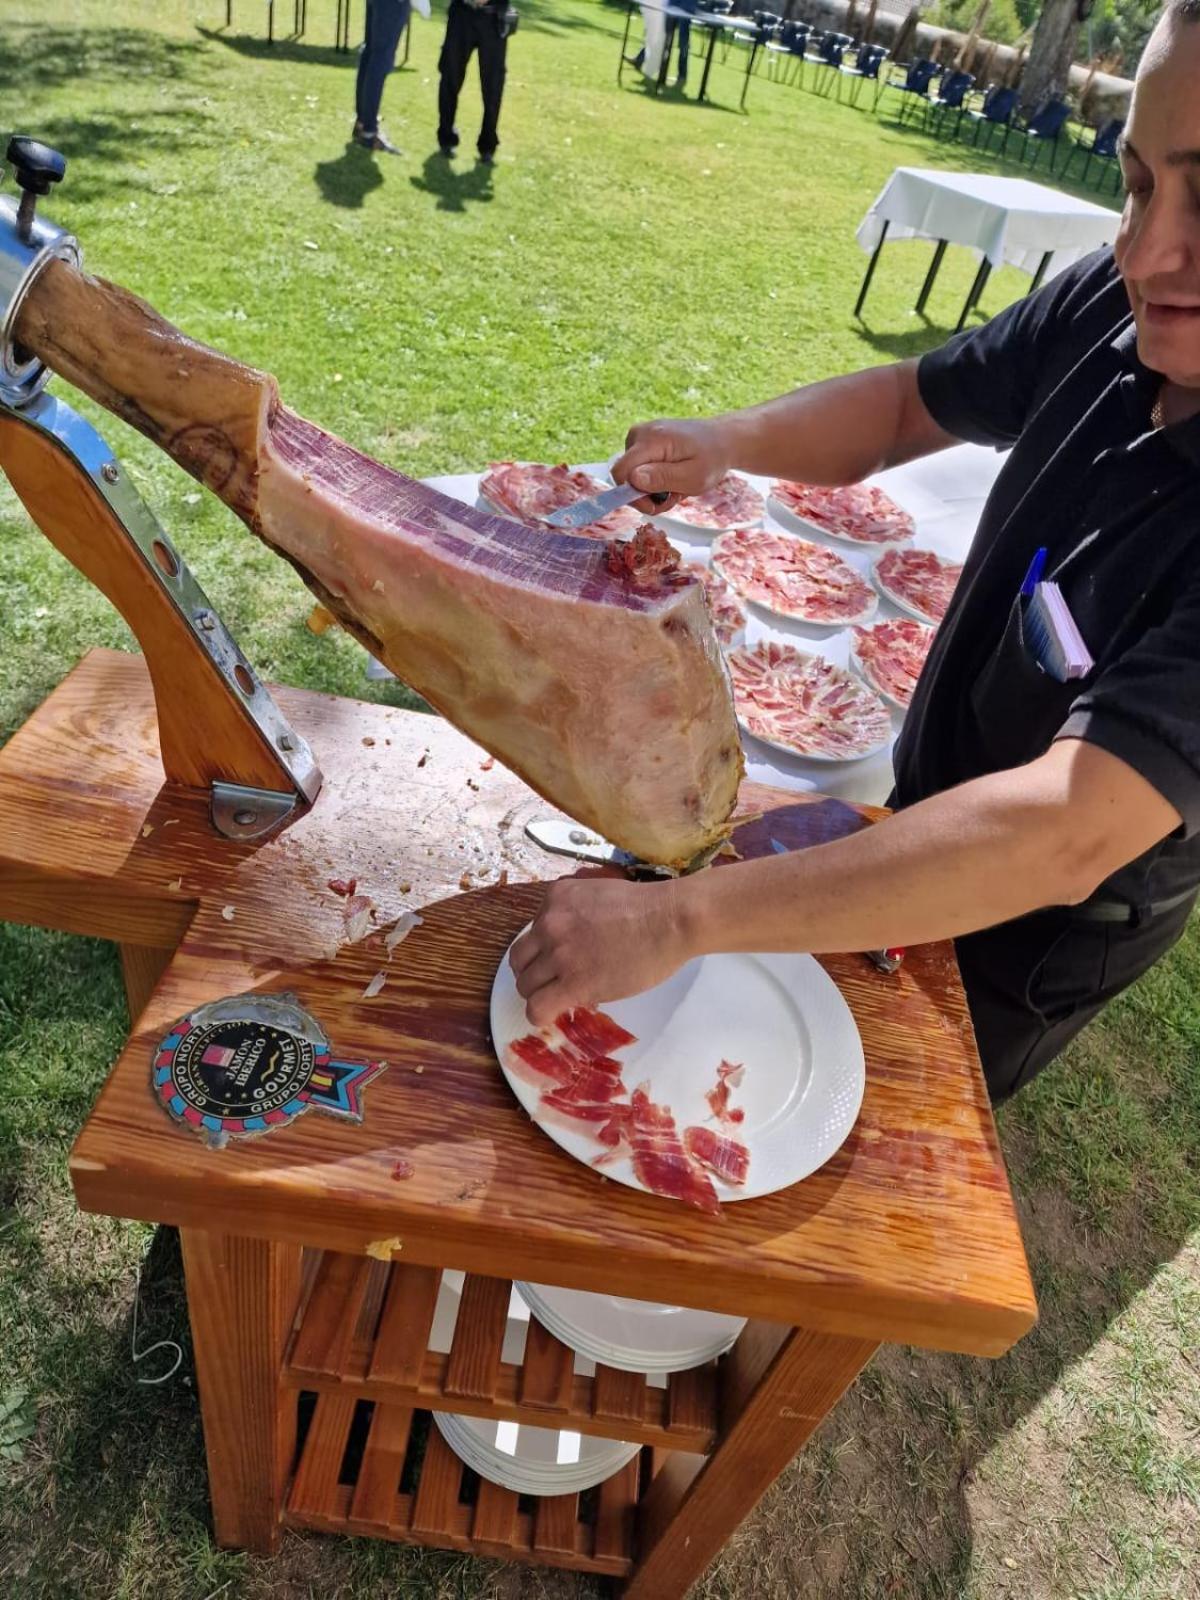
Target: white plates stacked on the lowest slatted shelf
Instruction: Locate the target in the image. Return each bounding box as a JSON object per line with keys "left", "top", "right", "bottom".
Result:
{"left": 434, "top": 1411, "right": 642, "bottom": 1494}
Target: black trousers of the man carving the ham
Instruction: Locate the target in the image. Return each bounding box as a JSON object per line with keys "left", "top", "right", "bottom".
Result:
{"left": 955, "top": 902, "right": 1192, "bottom": 1101}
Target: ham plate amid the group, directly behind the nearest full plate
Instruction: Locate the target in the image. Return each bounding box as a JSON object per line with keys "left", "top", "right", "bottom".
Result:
{"left": 712, "top": 528, "right": 878, "bottom": 627}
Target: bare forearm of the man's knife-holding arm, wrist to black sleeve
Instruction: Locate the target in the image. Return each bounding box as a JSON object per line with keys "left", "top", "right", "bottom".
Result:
{"left": 717, "top": 362, "right": 954, "bottom": 483}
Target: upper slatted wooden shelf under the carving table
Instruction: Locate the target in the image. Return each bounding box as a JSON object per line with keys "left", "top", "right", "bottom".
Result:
{"left": 283, "top": 1251, "right": 718, "bottom": 1454}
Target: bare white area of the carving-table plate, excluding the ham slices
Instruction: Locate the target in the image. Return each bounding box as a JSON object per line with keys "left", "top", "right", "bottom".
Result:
{"left": 491, "top": 950, "right": 866, "bottom": 1205}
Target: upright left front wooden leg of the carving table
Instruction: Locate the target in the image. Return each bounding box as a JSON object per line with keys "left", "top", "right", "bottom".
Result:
{"left": 179, "top": 1227, "right": 301, "bottom": 1555}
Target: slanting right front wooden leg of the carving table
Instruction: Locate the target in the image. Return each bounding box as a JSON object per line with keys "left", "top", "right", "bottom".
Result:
{"left": 622, "top": 1322, "right": 878, "bottom": 1600}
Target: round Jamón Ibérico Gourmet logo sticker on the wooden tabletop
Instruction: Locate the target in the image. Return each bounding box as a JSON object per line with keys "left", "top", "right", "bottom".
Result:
{"left": 154, "top": 994, "right": 382, "bottom": 1147}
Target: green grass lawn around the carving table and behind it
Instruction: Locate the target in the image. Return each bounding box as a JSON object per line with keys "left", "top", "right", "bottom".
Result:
{"left": 0, "top": 0, "right": 1200, "bottom": 1600}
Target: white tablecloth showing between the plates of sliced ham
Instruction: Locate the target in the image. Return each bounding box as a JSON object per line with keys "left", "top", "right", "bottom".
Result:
{"left": 385, "top": 445, "right": 1003, "bottom": 805}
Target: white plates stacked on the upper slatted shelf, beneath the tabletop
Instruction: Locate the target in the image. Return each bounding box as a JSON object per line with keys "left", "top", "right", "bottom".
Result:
{"left": 514, "top": 1283, "right": 746, "bottom": 1374}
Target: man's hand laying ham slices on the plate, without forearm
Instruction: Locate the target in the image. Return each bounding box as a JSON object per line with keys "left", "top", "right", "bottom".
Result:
{"left": 512, "top": 869, "right": 694, "bottom": 1027}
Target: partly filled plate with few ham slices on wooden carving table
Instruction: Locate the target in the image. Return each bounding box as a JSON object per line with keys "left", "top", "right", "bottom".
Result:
{"left": 491, "top": 934, "right": 866, "bottom": 1214}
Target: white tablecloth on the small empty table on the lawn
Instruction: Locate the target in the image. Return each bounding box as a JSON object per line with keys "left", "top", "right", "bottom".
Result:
{"left": 856, "top": 166, "right": 1120, "bottom": 277}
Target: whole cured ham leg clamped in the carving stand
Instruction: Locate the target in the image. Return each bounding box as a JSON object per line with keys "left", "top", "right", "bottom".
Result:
{"left": 16, "top": 262, "right": 742, "bottom": 866}
